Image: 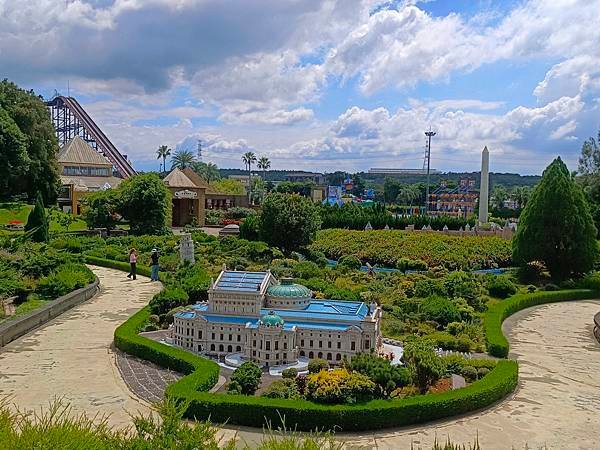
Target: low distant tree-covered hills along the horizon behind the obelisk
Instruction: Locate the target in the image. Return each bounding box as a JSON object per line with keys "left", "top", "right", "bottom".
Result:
{"left": 220, "top": 169, "right": 541, "bottom": 187}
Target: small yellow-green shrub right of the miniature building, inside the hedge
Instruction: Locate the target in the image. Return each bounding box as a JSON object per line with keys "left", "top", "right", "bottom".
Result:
{"left": 402, "top": 338, "right": 446, "bottom": 394}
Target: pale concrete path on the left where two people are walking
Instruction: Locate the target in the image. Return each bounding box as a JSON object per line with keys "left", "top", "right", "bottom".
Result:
{"left": 0, "top": 267, "right": 160, "bottom": 426}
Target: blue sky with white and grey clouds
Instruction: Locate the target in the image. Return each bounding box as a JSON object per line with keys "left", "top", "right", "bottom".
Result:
{"left": 0, "top": 0, "right": 600, "bottom": 174}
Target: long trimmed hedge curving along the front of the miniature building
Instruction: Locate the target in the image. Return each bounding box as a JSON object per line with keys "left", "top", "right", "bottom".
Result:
{"left": 167, "top": 360, "right": 518, "bottom": 431}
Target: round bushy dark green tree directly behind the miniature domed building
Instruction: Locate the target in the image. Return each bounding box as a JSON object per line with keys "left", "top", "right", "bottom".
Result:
{"left": 260, "top": 193, "right": 321, "bottom": 252}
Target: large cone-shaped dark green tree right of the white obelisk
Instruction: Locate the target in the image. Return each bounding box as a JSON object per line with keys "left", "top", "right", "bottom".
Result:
{"left": 513, "top": 157, "right": 597, "bottom": 281}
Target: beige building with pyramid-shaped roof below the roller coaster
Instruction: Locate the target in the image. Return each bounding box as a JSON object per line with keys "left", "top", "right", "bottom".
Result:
{"left": 57, "top": 136, "right": 123, "bottom": 214}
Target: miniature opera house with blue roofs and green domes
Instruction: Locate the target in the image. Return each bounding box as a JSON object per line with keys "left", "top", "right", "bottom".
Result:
{"left": 171, "top": 270, "right": 382, "bottom": 367}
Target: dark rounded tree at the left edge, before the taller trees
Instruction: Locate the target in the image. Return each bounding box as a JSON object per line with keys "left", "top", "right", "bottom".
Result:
{"left": 0, "top": 105, "right": 30, "bottom": 196}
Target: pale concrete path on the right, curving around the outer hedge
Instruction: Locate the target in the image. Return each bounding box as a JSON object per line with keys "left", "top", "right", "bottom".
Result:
{"left": 222, "top": 300, "right": 600, "bottom": 450}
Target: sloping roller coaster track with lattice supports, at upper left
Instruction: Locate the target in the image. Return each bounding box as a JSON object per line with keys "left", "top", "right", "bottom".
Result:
{"left": 46, "top": 95, "right": 136, "bottom": 178}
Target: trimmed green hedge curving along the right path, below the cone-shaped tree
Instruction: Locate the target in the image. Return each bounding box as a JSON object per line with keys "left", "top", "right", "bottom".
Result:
{"left": 484, "top": 289, "right": 599, "bottom": 358}
